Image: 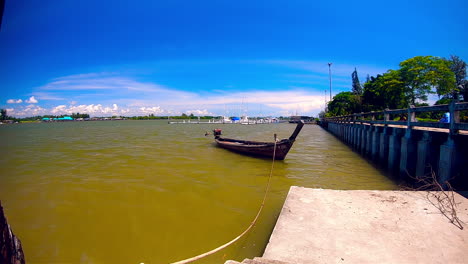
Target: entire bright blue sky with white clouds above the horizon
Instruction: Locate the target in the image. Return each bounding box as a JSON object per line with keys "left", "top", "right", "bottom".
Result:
{"left": 0, "top": 0, "right": 468, "bottom": 117}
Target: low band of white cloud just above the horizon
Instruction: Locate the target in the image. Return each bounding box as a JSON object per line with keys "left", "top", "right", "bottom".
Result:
{"left": 4, "top": 87, "right": 324, "bottom": 117}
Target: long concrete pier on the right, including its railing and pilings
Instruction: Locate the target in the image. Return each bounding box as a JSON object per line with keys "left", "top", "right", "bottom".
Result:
{"left": 318, "top": 101, "right": 468, "bottom": 190}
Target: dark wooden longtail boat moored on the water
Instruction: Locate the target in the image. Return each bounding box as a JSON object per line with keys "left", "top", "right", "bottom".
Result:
{"left": 213, "top": 120, "right": 304, "bottom": 160}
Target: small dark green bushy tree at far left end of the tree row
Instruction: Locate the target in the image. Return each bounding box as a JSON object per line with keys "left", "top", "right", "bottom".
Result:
{"left": 328, "top": 92, "right": 361, "bottom": 116}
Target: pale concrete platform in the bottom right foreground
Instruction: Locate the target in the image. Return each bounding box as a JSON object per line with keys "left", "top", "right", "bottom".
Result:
{"left": 263, "top": 186, "right": 468, "bottom": 263}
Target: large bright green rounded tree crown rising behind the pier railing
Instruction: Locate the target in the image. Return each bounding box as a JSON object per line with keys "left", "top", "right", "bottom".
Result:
{"left": 399, "top": 56, "right": 455, "bottom": 104}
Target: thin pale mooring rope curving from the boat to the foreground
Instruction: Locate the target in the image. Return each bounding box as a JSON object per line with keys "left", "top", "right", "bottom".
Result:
{"left": 170, "top": 137, "right": 277, "bottom": 264}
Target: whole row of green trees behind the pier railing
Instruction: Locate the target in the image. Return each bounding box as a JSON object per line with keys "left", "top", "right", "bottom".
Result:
{"left": 321, "top": 55, "right": 468, "bottom": 121}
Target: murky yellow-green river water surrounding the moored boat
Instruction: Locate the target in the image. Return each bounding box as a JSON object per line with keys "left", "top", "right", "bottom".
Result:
{"left": 0, "top": 121, "right": 397, "bottom": 263}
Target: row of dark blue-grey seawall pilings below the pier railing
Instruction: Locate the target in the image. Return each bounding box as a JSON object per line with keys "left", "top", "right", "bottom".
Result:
{"left": 321, "top": 122, "right": 468, "bottom": 190}
